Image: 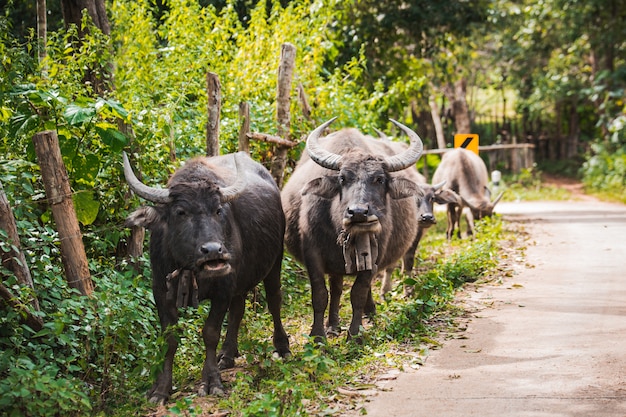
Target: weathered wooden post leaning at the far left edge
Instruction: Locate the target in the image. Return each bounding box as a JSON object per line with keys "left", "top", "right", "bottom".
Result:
{"left": 0, "top": 182, "right": 39, "bottom": 311}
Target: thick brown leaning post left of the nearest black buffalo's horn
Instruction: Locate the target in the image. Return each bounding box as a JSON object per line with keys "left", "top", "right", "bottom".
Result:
{"left": 33, "top": 130, "right": 93, "bottom": 295}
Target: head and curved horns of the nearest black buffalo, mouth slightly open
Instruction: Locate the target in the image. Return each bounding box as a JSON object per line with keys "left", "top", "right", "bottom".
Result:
{"left": 123, "top": 153, "right": 246, "bottom": 278}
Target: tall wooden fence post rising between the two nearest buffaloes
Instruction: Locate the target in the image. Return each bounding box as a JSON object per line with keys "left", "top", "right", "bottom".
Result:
{"left": 270, "top": 43, "right": 296, "bottom": 187}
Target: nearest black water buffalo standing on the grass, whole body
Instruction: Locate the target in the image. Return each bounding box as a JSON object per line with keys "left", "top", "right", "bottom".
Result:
{"left": 124, "top": 152, "right": 290, "bottom": 402}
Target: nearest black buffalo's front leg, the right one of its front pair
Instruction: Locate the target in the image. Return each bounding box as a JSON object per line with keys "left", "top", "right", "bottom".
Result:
{"left": 198, "top": 298, "right": 229, "bottom": 396}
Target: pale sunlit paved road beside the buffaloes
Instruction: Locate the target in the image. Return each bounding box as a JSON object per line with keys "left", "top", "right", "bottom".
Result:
{"left": 354, "top": 201, "right": 626, "bottom": 417}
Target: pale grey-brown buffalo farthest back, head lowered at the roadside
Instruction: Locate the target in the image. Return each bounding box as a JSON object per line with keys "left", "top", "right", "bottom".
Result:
{"left": 433, "top": 148, "right": 502, "bottom": 239}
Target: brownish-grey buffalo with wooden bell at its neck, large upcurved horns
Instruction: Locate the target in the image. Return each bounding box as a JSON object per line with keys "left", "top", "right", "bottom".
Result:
{"left": 282, "top": 119, "right": 423, "bottom": 339}
